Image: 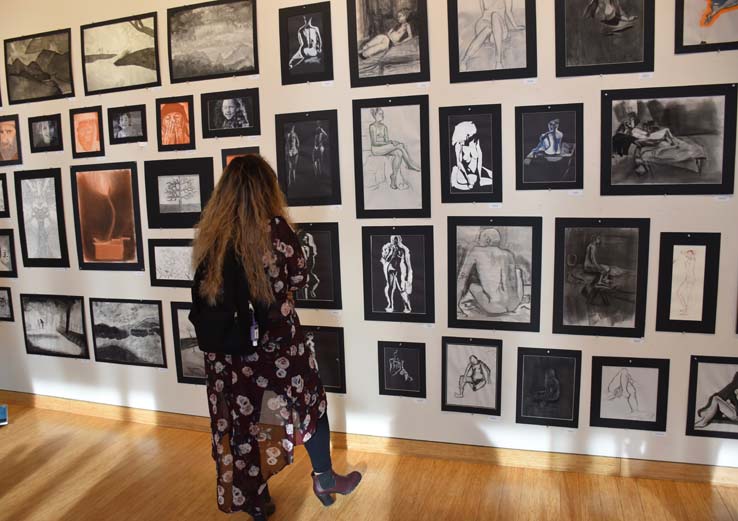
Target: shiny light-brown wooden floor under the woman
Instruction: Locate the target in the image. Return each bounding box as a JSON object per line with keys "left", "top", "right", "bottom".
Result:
{"left": 0, "top": 406, "right": 738, "bottom": 521}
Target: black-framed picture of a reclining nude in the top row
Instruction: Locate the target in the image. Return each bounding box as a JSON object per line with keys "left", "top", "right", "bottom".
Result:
{"left": 346, "top": 0, "right": 430, "bottom": 87}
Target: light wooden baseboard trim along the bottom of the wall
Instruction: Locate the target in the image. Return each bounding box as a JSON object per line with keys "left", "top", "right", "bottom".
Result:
{"left": 0, "top": 390, "right": 738, "bottom": 487}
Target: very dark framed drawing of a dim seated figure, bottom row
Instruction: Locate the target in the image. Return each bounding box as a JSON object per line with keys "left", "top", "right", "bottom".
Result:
{"left": 515, "top": 347, "right": 582, "bottom": 429}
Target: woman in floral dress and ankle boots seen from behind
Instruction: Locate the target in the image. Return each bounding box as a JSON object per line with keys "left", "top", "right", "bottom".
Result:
{"left": 192, "top": 155, "right": 361, "bottom": 520}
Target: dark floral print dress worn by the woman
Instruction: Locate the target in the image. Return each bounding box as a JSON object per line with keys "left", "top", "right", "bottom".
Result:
{"left": 205, "top": 217, "right": 326, "bottom": 515}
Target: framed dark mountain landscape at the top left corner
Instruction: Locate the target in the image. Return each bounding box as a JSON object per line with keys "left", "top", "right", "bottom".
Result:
{"left": 5, "top": 29, "right": 74, "bottom": 105}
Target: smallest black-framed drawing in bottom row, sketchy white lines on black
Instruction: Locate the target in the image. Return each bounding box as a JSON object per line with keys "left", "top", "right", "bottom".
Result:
{"left": 377, "top": 342, "right": 425, "bottom": 398}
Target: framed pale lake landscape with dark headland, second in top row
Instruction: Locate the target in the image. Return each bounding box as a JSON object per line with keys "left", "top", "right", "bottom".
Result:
{"left": 80, "top": 12, "right": 161, "bottom": 96}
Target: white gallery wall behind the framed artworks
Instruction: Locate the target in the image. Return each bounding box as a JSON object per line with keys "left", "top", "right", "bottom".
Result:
{"left": 0, "top": 0, "right": 738, "bottom": 466}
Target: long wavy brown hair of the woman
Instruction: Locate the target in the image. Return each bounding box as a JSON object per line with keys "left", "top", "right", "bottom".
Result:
{"left": 192, "top": 154, "right": 289, "bottom": 305}
